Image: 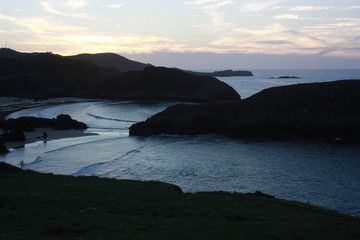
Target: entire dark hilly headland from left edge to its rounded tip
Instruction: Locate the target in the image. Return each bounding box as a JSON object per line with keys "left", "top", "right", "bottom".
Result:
{"left": 0, "top": 48, "right": 240, "bottom": 102}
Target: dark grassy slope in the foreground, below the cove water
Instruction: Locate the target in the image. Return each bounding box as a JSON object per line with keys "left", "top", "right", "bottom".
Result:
{"left": 0, "top": 163, "right": 360, "bottom": 240}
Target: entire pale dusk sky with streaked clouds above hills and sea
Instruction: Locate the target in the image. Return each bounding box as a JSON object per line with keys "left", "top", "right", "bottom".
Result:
{"left": 0, "top": 0, "right": 360, "bottom": 69}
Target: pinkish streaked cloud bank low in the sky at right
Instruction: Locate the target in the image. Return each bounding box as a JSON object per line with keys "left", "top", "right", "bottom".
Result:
{"left": 205, "top": 19, "right": 353, "bottom": 56}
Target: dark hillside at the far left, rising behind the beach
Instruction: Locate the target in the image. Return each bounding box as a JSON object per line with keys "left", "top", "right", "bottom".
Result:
{"left": 0, "top": 50, "right": 117, "bottom": 98}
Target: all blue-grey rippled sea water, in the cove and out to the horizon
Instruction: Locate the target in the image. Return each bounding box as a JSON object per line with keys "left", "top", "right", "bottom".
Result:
{"left": 0, "top": 70, "right": 360, "bottom": 216}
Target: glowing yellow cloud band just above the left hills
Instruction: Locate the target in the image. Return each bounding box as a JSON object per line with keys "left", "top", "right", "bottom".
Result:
{"left": 5, "top": 32, "right": 187, "bottom": 55}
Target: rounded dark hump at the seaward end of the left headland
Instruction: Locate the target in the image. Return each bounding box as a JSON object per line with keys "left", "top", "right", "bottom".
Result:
{"left": 99, "top": 67, "right": 240, "bottom": 102}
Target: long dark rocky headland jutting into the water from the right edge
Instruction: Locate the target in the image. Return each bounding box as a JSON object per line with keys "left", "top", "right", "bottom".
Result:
{"left": 130, "top": 80, "right": 360, "bottom": 139}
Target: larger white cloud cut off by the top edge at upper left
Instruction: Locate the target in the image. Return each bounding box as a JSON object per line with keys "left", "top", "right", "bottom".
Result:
{"left": 40, "top": 0, "right": 90, "bottom": 19}
